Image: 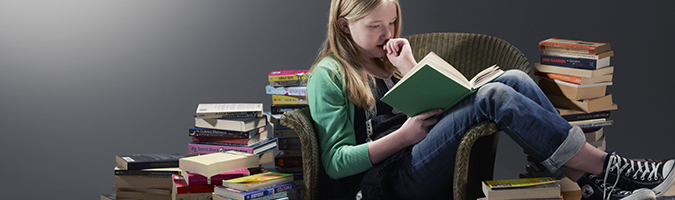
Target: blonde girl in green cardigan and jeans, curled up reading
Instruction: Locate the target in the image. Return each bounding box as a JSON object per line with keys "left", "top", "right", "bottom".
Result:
{"left": 307, "top": 0, "right": 675, "bottom": 199}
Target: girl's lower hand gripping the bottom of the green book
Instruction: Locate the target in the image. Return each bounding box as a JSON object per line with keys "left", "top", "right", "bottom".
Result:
{"left": 397, "top": 109, "right": 443, "bottom": 146}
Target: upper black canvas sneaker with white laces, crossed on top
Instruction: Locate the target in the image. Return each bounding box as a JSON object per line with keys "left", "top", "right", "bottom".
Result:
{"left": 603, "top": 153, "right": 675, "bottom": 196}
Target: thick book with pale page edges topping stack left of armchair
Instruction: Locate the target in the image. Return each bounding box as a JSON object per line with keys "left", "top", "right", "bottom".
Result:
{"left": 196, "top": 103, "right": 263, "bottom": 118}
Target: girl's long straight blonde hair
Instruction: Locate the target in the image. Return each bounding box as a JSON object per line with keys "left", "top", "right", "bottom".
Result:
{"left": 310, "top": 0, "right": 401, "bottom": 109}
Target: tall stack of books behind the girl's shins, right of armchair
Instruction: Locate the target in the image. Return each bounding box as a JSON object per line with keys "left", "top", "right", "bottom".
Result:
{"left": 534, "top": 38, "right": 618, "bottom": 150}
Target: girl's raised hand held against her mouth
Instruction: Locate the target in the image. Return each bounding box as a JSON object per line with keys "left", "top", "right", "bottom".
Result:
{"left": 382, "top": 38, "right": 417, "bottom": 75}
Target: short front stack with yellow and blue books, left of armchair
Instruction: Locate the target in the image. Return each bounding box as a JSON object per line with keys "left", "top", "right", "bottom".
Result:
{"left": 213, "top": 172, "right": 296, "bottom": 200}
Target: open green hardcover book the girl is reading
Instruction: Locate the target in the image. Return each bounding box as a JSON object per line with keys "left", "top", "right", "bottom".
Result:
{"left": 380, "top": 52, "right": 504, "bottom": 116}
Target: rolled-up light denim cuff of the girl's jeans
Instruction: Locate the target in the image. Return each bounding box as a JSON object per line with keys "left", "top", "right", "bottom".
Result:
{"left": 541, "top": 126, "right": 586, "bottom": 175}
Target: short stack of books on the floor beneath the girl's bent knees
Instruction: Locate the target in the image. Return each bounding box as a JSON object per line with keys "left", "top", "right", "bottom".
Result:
{"left": 479, "top": 177, "right": 563, "bottom": 200}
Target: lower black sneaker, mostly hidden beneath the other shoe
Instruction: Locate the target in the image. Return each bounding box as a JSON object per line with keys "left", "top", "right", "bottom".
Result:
{"left": 577, "top": 173, "right": 656, "bottom": 200}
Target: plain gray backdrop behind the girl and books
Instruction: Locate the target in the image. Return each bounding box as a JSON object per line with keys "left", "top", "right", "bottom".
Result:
{"left": 0, "top": 0, "right": 675, "bottom": 199}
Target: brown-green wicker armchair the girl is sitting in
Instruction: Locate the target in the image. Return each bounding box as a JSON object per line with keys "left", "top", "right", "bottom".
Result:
{"left": 281, "top": 33, "right": 532, "bottom": 199}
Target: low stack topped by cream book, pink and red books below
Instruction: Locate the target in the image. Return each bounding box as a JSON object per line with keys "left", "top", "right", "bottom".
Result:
{"left": 178, "top": 151, "right": 260, "bottom": 200}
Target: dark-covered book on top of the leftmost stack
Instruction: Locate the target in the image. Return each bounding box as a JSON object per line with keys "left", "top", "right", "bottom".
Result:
{"left": 115, "top": 154, "right": 183, "bottom": 170}
